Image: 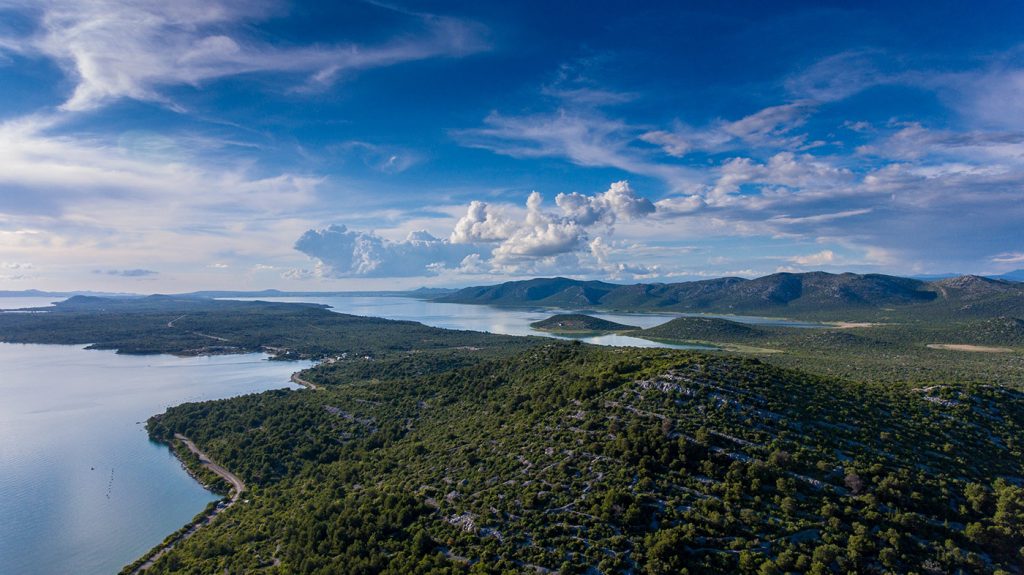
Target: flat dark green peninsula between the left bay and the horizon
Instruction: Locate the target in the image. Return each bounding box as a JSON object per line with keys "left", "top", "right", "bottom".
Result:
{"left": 0, "top": 296, "right": 529, "bottom": 359}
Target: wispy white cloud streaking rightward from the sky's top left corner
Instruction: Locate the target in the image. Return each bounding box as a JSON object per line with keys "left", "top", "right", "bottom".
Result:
{"left": 0, "top": 0, "right": 485, "bottom": 110}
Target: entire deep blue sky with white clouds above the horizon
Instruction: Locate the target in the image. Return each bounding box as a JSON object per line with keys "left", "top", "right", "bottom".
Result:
{"left": 0, "top": 0, "right": 1024, "bottom": 293}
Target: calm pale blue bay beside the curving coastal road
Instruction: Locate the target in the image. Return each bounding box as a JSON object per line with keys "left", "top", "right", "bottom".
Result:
{"left": 0, "top": 344, "right": 309, "bottom": 575}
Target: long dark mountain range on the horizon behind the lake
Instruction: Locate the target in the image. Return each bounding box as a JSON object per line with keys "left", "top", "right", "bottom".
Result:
{"left": 436, "top": 271, "right": 1024, "bottom": 316}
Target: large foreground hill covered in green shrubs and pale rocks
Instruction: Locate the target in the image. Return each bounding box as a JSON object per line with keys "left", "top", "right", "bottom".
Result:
{"left": 150, "top": 343, "right": 1024, "bottom": 573}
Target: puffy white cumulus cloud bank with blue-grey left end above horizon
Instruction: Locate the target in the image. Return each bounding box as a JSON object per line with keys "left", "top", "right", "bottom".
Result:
{"left": 295, "top": 181, "right": 655, "bottom": 277}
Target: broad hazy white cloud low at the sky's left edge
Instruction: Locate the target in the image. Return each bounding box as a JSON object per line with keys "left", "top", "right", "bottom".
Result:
{"left": 0, "top": 113, "right": 324, "bottom": 278}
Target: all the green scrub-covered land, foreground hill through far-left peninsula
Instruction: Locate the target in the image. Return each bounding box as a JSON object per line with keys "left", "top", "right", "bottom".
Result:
{"left": 0, "top": 298, "right": 1024, "bottom": 575}
